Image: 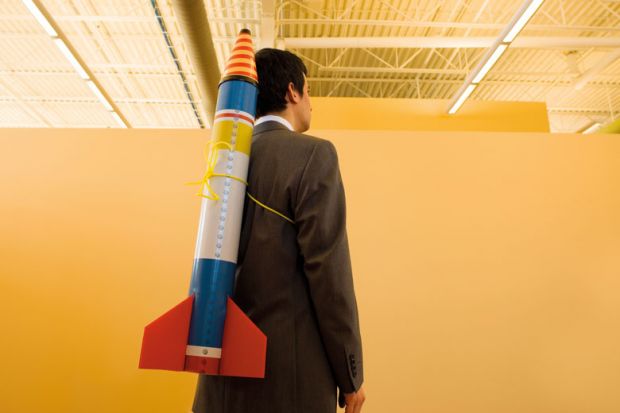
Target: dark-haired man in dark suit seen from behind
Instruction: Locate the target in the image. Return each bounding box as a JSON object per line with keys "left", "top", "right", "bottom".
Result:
{"left": 194, "top": 49, "right": 365, "bottom": 413}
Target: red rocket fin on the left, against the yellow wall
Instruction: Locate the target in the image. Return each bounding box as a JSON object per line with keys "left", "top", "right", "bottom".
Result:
{"left": 139, "top": 295, "right": 194, "bottom": 371}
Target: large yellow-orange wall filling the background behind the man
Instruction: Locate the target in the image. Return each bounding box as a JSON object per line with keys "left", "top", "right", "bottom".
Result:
{"left": 0, "top": 129, "right": 620, "bottom": 413}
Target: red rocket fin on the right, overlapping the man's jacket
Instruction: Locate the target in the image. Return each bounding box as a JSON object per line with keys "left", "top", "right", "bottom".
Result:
{"left": 220, "top": 297, "right": 267, "bottom": 378}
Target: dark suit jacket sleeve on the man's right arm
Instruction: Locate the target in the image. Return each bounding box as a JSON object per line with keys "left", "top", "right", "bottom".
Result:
{"left": 293, "top": 140, "right": 364, "bottom": 393}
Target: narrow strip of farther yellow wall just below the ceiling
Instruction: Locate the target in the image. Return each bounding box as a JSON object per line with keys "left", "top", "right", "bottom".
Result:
{"left": 312, "top": 97, "right": 549, "bottom": 132}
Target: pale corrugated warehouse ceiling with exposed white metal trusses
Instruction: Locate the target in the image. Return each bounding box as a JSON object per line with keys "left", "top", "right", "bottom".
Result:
{"left": 0, "top": 0, "right": 620, "bottom": 133}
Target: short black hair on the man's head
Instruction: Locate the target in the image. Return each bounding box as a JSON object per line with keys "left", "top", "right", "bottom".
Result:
{"left": 256, "top": 48, "right": 308, "bottom": 118}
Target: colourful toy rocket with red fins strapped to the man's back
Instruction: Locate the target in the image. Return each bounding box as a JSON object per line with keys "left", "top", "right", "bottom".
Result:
{"left": 139, "top": 29, "right": 267, "bottom": 377}
